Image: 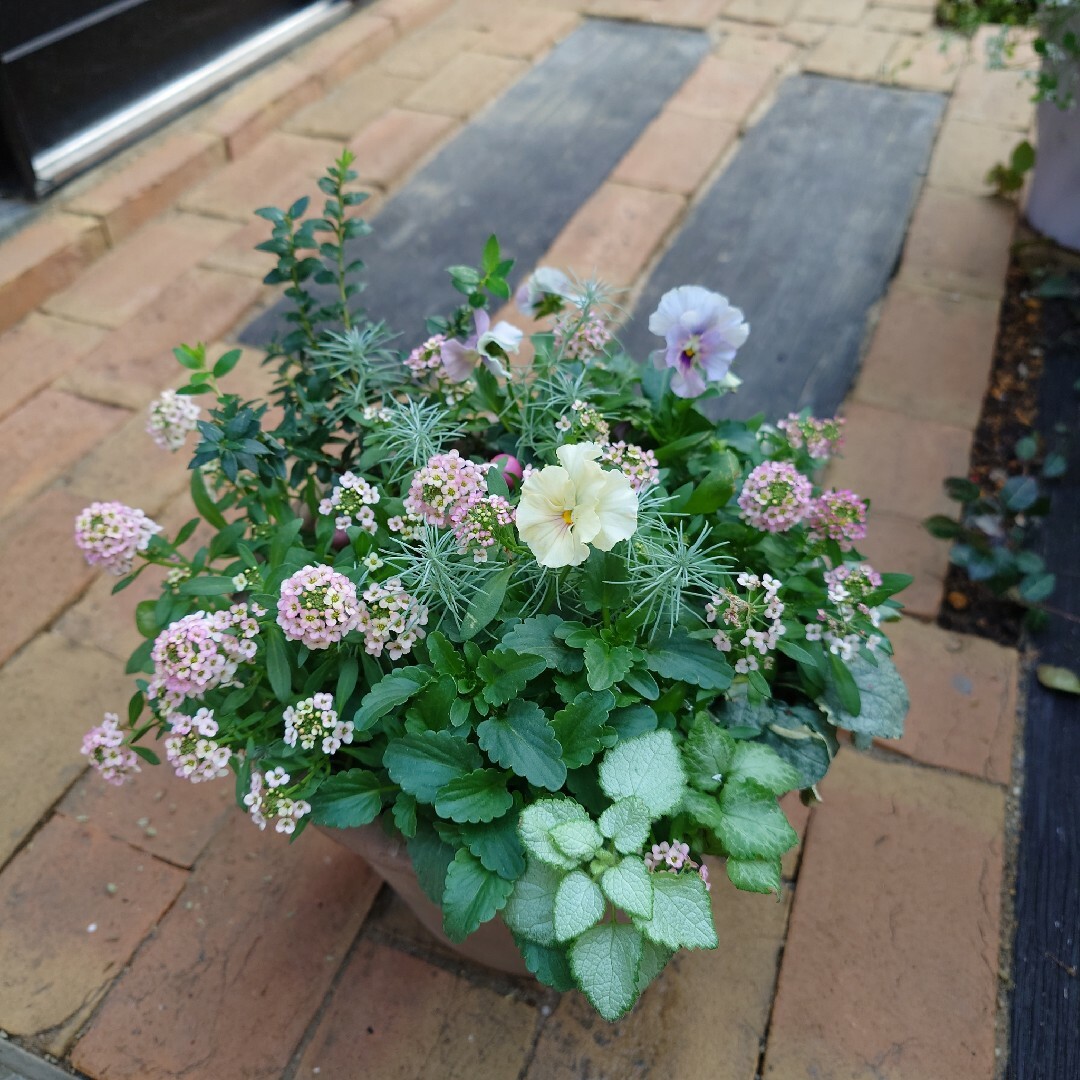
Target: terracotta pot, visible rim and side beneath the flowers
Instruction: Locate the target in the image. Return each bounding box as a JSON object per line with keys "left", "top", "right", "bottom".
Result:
{"left": 321, "top": 822, "right": 531, "bottom": 977}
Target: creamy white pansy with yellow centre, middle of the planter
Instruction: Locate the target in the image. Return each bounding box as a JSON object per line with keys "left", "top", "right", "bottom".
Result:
{"left": 517, "top": 443, "right": 637, "bottom": 567}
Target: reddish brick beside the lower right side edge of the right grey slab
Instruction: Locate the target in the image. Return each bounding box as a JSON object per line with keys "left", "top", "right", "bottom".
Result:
{"left": 854, "top": 284, "right": 998, "bottom": 429}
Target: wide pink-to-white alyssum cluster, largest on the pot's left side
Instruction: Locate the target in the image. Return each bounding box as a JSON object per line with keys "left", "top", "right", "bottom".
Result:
{"left": 147, "top": 604, "right": 266, "bottom": 712}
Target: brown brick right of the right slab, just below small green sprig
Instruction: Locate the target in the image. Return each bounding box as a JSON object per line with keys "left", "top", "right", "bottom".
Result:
{"left": 900, "top": 187, "right": 1016, "bottom": 299}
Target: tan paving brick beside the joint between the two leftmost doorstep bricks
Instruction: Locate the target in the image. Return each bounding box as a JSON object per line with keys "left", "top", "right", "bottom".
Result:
{"left": 44, "top": 215, "right": 233, "bottom": 328}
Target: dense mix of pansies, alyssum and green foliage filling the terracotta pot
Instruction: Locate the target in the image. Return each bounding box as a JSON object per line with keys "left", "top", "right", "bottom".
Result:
{"left": 77, "top": 153, "right": 909, "bottom": 1021}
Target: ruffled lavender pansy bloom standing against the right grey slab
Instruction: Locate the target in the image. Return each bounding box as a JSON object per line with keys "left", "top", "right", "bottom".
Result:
{"left": 649, "top": 285, "right": 750, "bottom": 397}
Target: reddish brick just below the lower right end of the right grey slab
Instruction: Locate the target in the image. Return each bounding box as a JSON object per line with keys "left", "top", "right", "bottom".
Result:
{"left": 827, "top": 403, "right": 971, "bottom": 522}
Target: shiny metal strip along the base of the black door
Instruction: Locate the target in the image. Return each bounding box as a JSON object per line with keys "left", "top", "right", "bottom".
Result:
{"left": 32, "top": 0, "right": 352, "bottom": 193}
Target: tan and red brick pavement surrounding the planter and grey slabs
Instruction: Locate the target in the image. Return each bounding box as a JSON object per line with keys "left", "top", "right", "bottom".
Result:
{"left": 0, "top": 0, "right": 1031, "bottom": 1080}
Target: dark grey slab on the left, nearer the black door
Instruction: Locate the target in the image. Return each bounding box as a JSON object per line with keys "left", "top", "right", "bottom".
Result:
{"left": 241, "top": 19, "right": 708, "bottom": 345}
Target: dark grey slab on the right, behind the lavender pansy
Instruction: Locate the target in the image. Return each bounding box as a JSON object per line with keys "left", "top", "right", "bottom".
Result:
{"left": 621, "top": 76, "right": 944, "bottom": 418}
